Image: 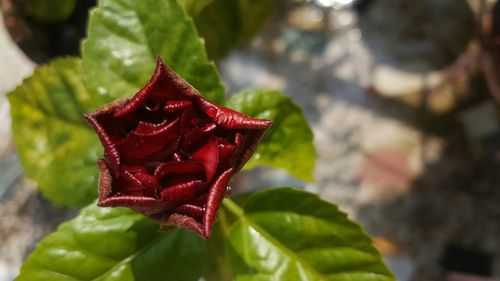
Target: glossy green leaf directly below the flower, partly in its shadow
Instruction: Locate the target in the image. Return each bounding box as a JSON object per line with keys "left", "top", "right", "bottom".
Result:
{"left": 15, "top": 202, "right": 204, "bottom": 281}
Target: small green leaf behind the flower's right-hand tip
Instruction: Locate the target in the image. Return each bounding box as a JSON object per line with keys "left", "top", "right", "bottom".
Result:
{"left": 228, "top": 90, "right": 316, "bottom": 181}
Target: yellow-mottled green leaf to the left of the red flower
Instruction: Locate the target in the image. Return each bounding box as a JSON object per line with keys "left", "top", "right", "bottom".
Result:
{"left": 8, "top": 58, "right": 102, "bottom": 207}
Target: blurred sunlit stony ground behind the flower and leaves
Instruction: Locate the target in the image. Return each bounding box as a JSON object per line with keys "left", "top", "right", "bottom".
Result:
{"left": 0, "top": 0, "right": 500, "bottom": 281}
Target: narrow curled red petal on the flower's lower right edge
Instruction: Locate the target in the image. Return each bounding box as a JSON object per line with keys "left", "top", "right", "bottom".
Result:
{"left": 203, "top": 168, "right": 233, "bottom": 237}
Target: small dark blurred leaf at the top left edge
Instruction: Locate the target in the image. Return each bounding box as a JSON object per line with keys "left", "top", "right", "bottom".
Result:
{"left": 24, "top": 0, "right": 76, "bottom": 23}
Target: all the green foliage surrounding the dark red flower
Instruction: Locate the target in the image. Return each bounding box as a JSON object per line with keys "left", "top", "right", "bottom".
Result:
{"left": 9, "top": 0, "right": 394, "bottom": 281}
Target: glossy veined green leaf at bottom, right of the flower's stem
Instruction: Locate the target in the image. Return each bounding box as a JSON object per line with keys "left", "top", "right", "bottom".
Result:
{"left": 226, "top": 188, "right": 395, "bottom": 281}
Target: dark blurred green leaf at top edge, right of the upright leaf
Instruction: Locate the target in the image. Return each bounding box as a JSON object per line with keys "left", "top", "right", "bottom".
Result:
{"left": 195, "top": 0, "right": 274, "bottom": 58}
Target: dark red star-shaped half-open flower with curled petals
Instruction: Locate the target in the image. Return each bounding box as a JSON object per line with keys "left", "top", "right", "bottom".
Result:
{"left": 85, "top": 58, "right": 272, "bottom": 238}
